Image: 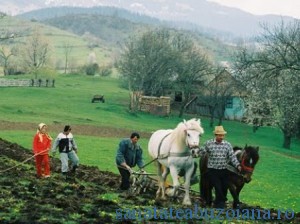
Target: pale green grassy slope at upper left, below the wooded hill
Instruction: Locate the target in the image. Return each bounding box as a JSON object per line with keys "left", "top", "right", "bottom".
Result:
{"left": 0, "top": 16, "right": 114, "bottom": 73}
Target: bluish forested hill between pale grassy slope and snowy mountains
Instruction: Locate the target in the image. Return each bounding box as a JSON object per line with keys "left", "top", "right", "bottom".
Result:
{"left": 19, "top": 6, "right": 229, "bottom": 61}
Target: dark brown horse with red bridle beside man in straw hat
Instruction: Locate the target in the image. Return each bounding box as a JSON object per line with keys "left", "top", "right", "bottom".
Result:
{"left": 199, "top": 145, "right": 259, "bottom": 208}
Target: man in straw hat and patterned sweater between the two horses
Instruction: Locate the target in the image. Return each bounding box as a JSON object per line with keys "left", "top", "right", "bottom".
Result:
{"left": 201, "top": 126, "right": 241, "bottom": 208}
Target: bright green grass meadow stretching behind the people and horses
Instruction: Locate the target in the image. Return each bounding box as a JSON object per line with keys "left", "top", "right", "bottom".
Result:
{"left": 0, "top": 75, "right": 300, "bottom": 212}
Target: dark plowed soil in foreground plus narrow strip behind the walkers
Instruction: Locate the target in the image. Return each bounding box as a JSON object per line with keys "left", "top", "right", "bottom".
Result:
{"left": 0, "top": 121, "right": 300, "bottom": 223}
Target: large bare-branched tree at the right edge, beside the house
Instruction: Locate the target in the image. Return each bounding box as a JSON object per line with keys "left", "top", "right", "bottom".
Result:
{"left": 235, "top": 20, "right": 300, "bottom": 148}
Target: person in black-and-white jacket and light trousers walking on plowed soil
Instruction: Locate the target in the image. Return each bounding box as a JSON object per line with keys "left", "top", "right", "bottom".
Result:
{"left": 51, "top": 125, "right": 79, "bottom": 179}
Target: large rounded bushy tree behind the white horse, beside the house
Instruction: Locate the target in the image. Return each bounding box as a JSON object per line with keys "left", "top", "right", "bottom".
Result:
{"left": 118, "top": 28, "right": 213, "bottom": 116}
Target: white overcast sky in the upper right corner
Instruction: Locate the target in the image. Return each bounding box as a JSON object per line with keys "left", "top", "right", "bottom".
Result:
{"left": 207, "top": 0, "right": 300, "bottom": 19}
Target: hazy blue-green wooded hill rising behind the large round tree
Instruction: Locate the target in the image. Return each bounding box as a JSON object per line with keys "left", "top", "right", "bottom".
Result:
{"left": 41, "top": 12, "right": 234, "bottom": 62}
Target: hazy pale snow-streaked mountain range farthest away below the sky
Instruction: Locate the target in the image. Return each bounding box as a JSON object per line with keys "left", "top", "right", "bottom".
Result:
{"left": 0, "top": 0, "right": 293, "bottom": 37}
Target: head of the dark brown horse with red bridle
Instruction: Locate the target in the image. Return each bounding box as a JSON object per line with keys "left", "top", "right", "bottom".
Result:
{"left": 240, "top": 145, "right": 259, "bottom": 183}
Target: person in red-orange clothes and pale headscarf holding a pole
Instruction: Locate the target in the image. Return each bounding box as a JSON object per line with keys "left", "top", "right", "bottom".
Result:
{"left": 33, "top": 123, "right": 52, "bottom": 178}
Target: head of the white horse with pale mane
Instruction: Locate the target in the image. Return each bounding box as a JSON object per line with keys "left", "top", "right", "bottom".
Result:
{"left": 183, "top": 118, "right": 204, "bottom": 157}
